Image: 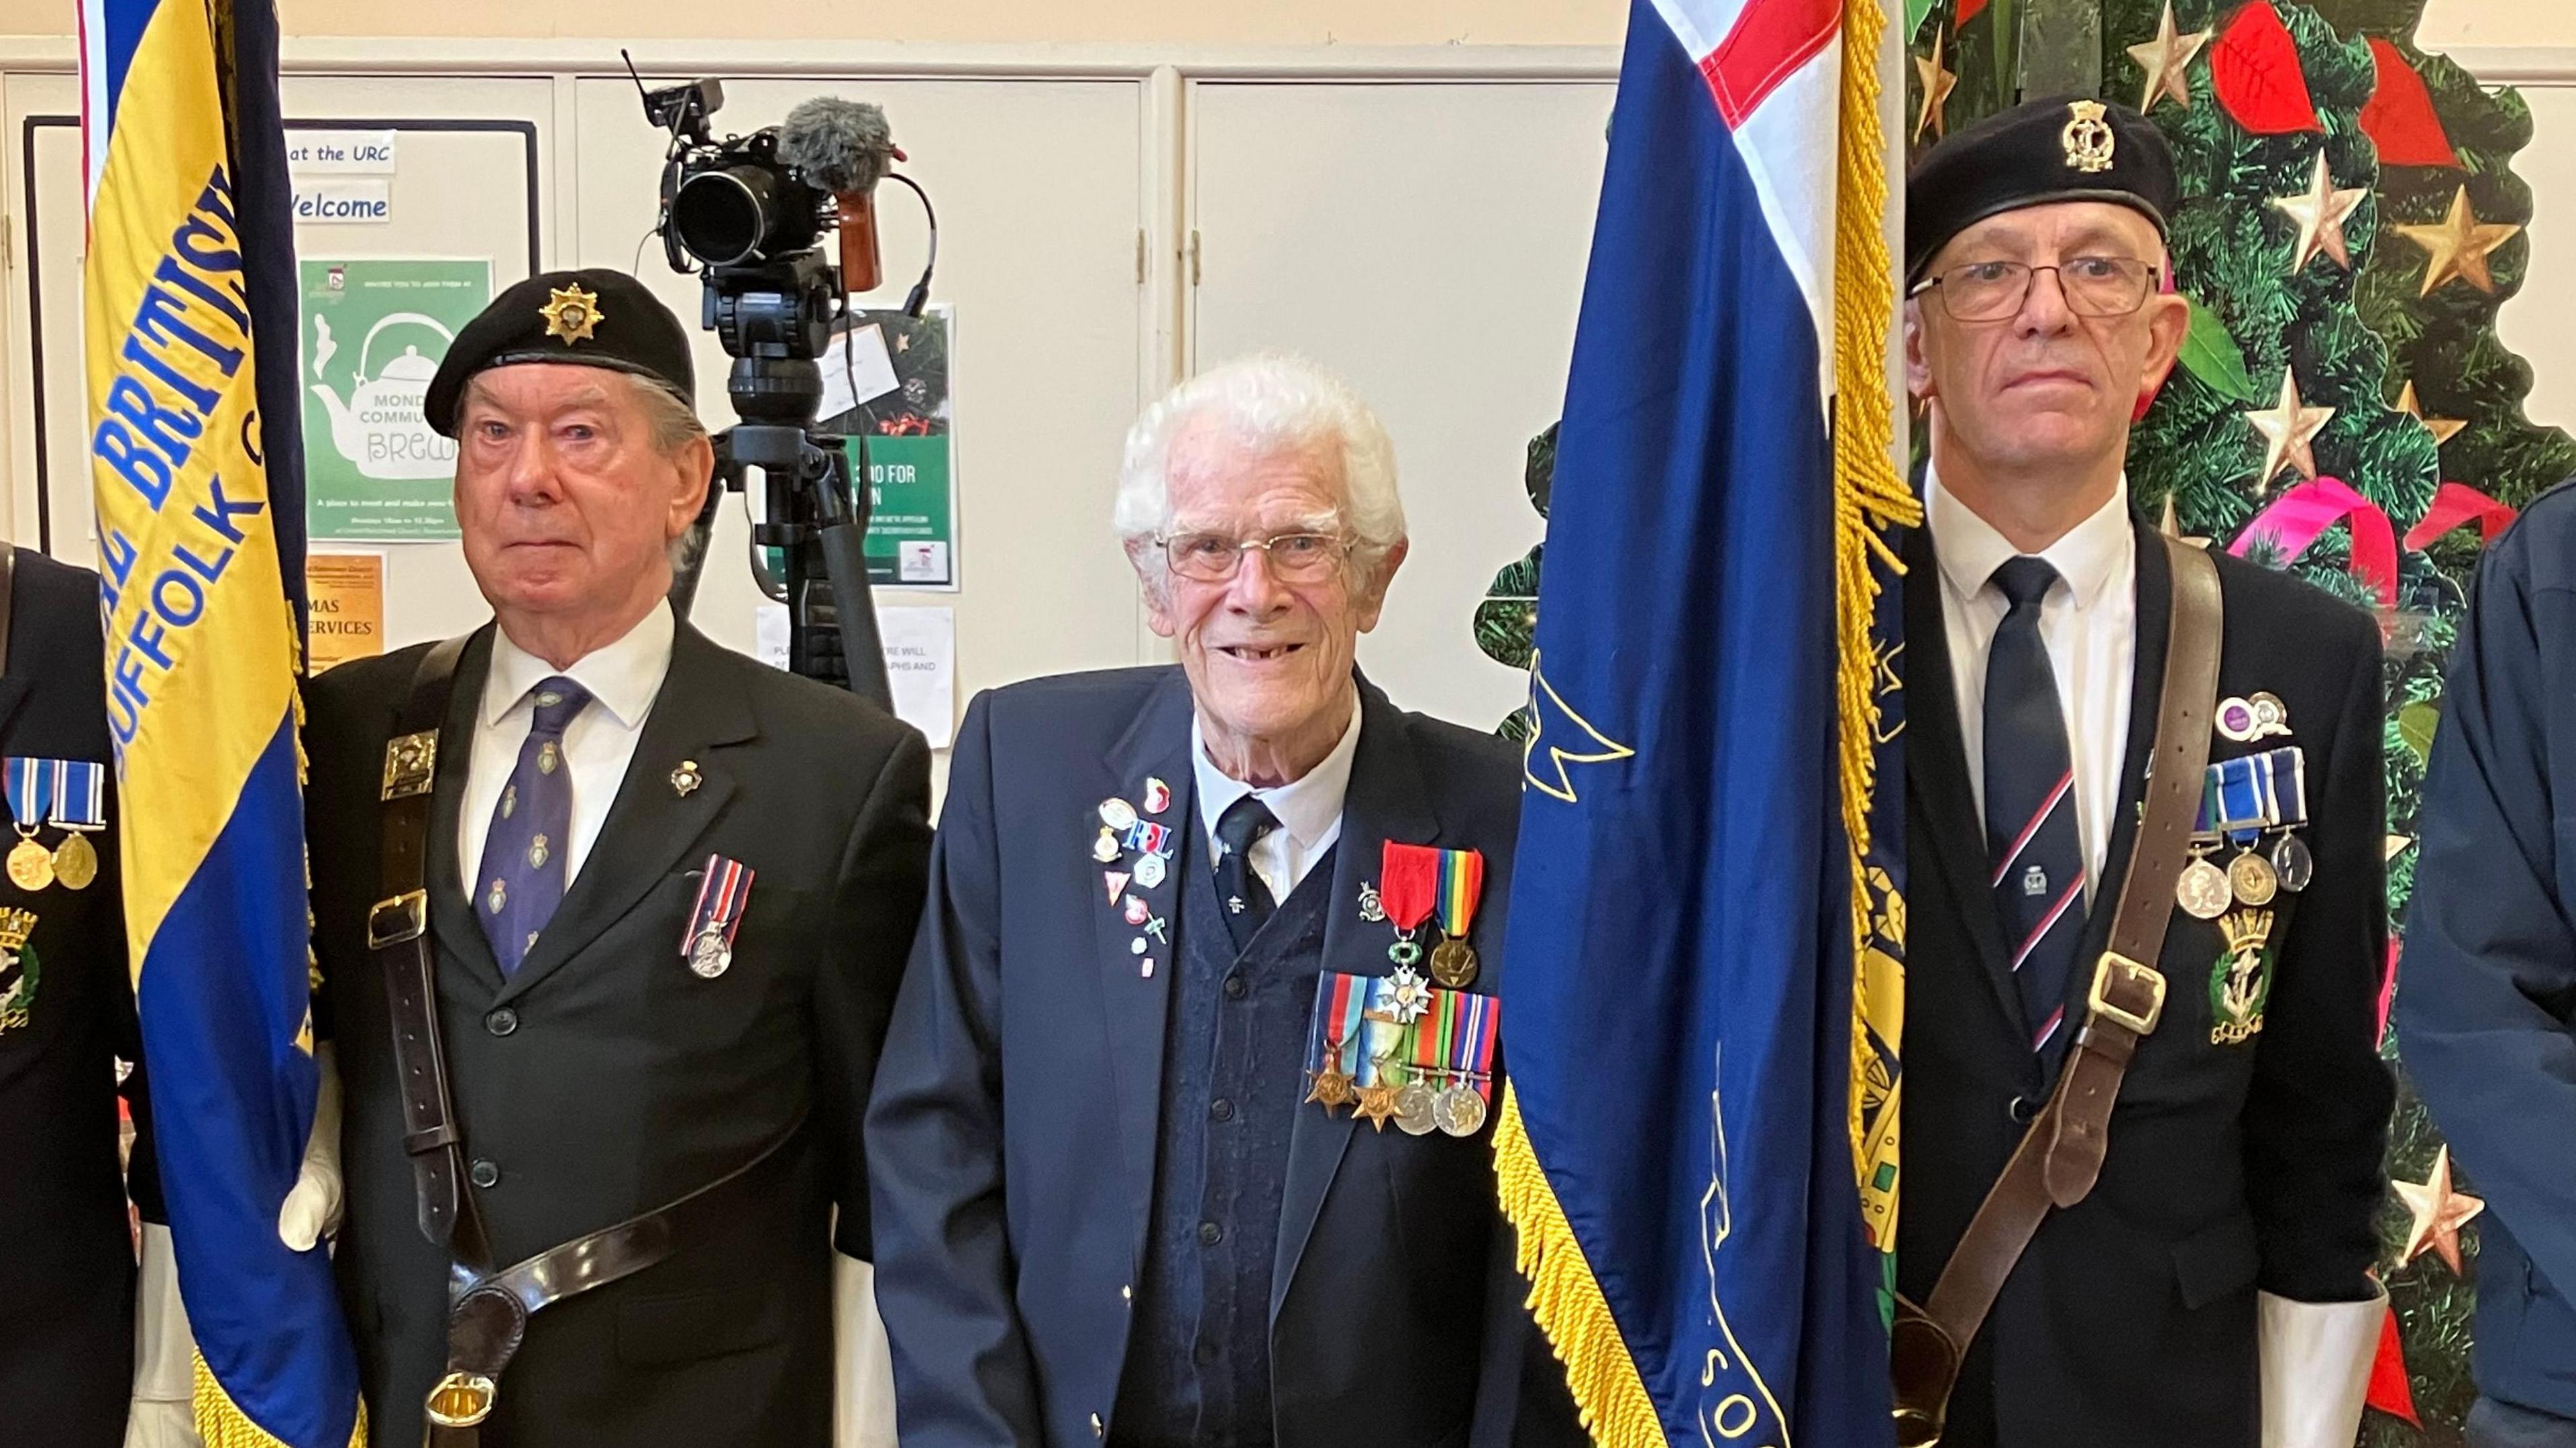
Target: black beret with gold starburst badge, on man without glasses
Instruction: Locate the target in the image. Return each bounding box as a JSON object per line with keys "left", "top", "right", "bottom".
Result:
{"left": 420, "top": 268, "right": 698, "bottom": 438}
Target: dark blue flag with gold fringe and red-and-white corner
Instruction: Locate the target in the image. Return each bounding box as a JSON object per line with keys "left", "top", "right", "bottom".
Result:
{"left": 1497, "top": 0, "right": 1914, "bottom": 1448}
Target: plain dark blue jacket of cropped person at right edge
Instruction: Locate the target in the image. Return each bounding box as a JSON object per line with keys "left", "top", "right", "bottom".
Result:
{"left": 2396, "top": 484, "right": 2576, "bottom": 1420}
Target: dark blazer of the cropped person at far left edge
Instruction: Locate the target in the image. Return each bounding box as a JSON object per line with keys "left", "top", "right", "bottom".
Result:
{"left": 0, "top": 544, "right": 162, "bottom": 1448}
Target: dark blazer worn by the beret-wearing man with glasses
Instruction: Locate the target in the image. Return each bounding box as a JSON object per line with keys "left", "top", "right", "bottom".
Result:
{"left": 1896, "top": 512, "right": 2393, "bottom": 1448}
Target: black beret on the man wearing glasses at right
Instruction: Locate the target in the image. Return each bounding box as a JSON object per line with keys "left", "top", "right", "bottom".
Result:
{"left": 1907, "top": 95, "right": 2182, "bottom": 286}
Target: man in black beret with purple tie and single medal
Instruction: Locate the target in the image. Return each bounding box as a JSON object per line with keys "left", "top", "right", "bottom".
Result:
{"left": 304, "top": 270, "right": 930, "bottom": 1448}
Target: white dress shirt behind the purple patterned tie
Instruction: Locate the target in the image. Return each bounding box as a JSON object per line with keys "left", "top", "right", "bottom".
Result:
{"left": 456, "top": 603, "right": 678, "bottom": 899}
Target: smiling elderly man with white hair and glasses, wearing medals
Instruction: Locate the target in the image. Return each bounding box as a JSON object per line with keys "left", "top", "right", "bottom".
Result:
{"left": 868, "top": 355, "right": 1585, "bottom": 1448}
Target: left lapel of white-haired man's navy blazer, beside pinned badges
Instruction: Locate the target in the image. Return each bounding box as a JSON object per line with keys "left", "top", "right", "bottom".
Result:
{"left": 1097, "top": 670, "right": 1200, "bottom": 1234}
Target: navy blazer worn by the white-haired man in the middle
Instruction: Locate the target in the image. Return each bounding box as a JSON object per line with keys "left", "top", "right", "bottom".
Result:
{"left": 868, "top": 667, "right": 1582, "bottom": 1448}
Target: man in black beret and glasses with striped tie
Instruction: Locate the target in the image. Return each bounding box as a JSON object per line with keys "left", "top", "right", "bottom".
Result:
{"left": 1896, "top": 98, "right": 2391, "bottom": 1448}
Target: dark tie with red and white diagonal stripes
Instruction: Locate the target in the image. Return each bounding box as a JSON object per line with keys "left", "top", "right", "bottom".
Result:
{"left": 1986, "top": 557, "right": 2084, "bottom": 1056}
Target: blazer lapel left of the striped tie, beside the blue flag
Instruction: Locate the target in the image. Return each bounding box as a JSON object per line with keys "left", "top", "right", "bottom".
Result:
{"left": 1904, "top": 512, "right": 2030, "bottom": 1044}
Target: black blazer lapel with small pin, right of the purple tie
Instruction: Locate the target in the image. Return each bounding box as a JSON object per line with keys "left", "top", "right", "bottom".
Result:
{"left": 492, "top": 624, "right": 760, "bottom": 1002}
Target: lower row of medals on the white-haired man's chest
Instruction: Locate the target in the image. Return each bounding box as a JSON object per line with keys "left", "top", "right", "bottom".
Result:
{"left": 1306, "top": 966, "right": 1502, "bottom": 1136}
